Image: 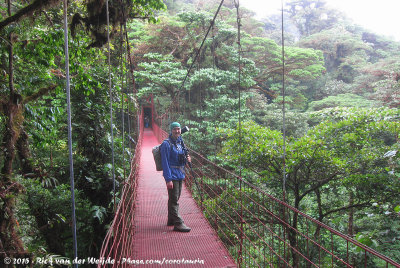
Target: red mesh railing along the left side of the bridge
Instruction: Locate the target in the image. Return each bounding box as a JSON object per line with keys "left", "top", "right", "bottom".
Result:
{"left": 97, "top": 110, "right": 144, "bottom": 267}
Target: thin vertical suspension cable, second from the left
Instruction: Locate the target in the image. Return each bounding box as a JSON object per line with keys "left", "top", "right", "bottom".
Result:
{"left": 106, "top": 0, "right": 116, "bottom": 212}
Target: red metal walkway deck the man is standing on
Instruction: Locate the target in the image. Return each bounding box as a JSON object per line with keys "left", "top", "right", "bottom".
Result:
{"left": 133, "top": 129, "right": 236, "bottom": 267}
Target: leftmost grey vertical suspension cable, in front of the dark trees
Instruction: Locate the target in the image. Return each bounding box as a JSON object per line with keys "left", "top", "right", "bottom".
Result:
{"left": 64, "top": 0, "right": 78, "bottom": 267}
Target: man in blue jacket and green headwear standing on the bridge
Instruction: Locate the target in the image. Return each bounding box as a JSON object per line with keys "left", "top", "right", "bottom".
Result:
{"left": 161, "top": 122, "right": 191, "bottom": 232}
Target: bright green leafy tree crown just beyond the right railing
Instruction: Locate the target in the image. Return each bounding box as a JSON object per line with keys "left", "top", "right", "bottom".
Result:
{"left": 222, "top": 110, "right": 399, "bottom": 213}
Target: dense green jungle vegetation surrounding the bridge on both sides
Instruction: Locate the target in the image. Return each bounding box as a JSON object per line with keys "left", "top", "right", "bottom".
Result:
{"left": 0, "top": 0, "right": 400, "bottom": 262}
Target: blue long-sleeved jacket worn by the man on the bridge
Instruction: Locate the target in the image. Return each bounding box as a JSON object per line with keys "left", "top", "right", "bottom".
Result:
{"left": 161, "top": 136, "right": 185, "bottom": 182}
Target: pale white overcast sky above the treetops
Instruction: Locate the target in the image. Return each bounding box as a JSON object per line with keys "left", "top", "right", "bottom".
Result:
{"left": 240, "top": 0, "right": 400, "bottom": 41}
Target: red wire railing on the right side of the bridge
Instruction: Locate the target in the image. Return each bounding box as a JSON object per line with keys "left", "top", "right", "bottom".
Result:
{"left": 186, "top": 151, "right": 400, "bottom": 268}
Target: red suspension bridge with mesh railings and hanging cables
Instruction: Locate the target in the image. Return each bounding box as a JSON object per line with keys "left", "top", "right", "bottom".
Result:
{"left": 52, "top": 0, "right": 400, "bottom": 267}
